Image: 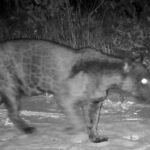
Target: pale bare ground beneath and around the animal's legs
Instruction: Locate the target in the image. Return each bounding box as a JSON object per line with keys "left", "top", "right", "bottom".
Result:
{"left": 0, "top": 95, "right": 150, "bottom": 150}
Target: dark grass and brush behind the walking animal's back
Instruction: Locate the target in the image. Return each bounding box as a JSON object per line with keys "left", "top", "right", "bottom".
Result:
{"left": 0, "top": 0, "right": 150, "bottom": 61}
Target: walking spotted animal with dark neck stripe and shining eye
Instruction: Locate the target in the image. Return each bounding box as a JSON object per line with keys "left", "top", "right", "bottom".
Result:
{"left": 0, "top": 40, "right": 150, "bottom": 142}
